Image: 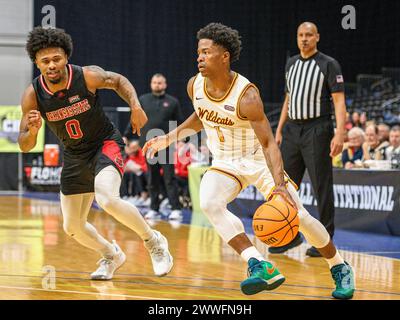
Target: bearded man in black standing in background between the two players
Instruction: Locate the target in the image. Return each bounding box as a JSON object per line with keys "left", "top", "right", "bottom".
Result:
{"left": 125, "top": 73, "right": 182, "bottom": 220}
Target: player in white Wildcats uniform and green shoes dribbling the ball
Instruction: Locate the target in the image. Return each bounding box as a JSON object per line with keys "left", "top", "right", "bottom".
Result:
{"left": 143, "top": 23, "right": 354, "bottom": 299}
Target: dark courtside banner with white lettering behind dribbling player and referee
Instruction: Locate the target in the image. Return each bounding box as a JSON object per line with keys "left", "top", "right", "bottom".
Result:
{"left": 228, "top": 169, "right": 400, "bottom": 236}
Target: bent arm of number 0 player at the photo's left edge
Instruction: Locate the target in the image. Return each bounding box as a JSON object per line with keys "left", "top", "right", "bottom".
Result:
{"left": 18, "top": 85, "right": 42, "bottom": 152}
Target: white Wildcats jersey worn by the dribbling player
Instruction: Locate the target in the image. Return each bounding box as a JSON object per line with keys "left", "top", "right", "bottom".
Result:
{"left": 193, "top": 72, "right": 260, "bottom": 160}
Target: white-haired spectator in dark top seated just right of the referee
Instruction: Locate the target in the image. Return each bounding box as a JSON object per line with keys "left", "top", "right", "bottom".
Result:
{"left": 342, "top": 127, "right": 364, "bottom": 169}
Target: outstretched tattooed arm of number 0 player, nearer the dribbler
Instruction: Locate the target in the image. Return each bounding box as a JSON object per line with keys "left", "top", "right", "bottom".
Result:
{"left": 83, "top": 66, "right": 148, "bottom": 135}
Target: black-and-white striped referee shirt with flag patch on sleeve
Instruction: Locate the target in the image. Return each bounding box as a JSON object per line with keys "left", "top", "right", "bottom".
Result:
{"left": 285, "top": 51, "right": 344, "bottom": 120}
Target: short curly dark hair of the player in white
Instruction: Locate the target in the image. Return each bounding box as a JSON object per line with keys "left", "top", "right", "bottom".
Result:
{"left": 197, "top": 22, "right": 242, "bottom": 63}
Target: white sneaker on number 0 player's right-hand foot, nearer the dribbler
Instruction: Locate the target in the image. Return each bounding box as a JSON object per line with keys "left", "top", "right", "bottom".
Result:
{"left": 144, "top": 230, "right": 174, "bottom": 277}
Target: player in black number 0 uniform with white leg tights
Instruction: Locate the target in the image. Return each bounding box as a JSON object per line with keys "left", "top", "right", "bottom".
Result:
{"left": 18, "top": 27, "right": 173, "bottom": 280}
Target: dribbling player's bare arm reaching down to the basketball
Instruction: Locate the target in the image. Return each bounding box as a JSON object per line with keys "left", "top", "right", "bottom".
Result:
{"left": 238, "top": 86, "right": 296, "bottom": 208}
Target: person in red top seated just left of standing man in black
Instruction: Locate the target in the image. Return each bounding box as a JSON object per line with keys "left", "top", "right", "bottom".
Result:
{"left": 124, "top": 140, "right": 150, "bottom": 206}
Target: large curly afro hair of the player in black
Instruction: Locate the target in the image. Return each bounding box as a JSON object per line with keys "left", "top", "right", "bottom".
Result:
{"left": 25, "top": 27, "right": 73, "bottom": 62}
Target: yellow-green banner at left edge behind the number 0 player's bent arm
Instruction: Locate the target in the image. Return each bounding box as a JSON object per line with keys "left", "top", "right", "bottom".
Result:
{"left": 0, "top": 106, "right": 44, "bottom": 153}
